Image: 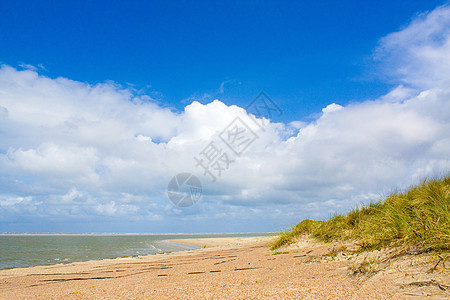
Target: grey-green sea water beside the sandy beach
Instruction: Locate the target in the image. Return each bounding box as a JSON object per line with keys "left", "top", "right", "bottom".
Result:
{"left": 0, "top": 233, "right": 272, "bottom": 270}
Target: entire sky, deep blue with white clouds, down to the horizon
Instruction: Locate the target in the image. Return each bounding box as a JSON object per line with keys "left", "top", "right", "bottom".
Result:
{"left": 0, "top": 0, "right": 450, "bottom": 232}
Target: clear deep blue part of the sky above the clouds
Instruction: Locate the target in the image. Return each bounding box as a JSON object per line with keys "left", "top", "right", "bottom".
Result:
{"left": 0, "top": 1, "right": 443, "bottom": 121}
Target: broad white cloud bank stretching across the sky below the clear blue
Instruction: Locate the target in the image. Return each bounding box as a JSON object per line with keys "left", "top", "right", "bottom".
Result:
{"left": 0, "top": 6, "right": 450, "bottom": 231}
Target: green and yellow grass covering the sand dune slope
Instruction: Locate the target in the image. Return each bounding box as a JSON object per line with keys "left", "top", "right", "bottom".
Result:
{"left": 272, "top": 175, "right": 450, "bottom": 251}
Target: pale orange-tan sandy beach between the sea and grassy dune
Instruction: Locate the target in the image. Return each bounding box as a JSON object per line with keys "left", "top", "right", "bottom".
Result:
{"left": 0, "top": 237, "right": 450, "bottom": 299}
